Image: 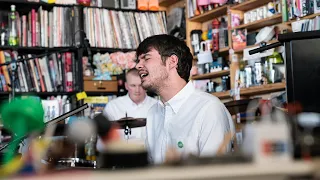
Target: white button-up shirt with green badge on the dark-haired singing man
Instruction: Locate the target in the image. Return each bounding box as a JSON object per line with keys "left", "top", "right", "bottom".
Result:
{"left": 147, "top": 82, "right": 235, "bottom": 164}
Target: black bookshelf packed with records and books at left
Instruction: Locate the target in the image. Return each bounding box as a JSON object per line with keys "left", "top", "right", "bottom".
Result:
{"left": 0, "top": 0, "right": 168, "bottom": 119}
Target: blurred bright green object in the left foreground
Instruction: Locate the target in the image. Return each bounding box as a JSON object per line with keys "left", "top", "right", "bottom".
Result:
{"left": 1, "top": 97, "right": 45, "bottom": 163}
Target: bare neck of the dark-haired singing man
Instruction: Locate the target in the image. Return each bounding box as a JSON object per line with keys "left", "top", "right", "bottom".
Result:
{"left": 158, "top": 77, "right": 187, "bottom": 103}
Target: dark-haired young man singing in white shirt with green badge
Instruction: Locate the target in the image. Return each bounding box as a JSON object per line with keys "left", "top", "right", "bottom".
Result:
{"left": 136, "top": 35, "right": 234, "bottom": 164}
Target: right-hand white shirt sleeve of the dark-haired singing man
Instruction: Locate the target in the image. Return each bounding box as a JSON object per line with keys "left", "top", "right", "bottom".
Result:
{"left": 199, "top": 102, "right": 229, "bottom": 156}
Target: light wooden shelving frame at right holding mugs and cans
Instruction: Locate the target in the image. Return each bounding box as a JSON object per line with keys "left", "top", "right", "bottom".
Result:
{"left": 185, "top": 0, "right": 320, "bottom": 103}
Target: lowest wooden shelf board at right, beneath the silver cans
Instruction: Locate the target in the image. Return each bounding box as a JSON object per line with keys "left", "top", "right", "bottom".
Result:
{"left": 240, "top": 83, "right": 286, "bottom": 96}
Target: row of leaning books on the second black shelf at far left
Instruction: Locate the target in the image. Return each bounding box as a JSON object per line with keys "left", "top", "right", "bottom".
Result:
{"left": 0, "top": 51, "right": 79, "bottom": 92}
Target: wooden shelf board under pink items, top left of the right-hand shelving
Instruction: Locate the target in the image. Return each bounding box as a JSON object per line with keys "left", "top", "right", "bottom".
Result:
{"left": 189, "top": 5, "right": 228, "bottom": 23}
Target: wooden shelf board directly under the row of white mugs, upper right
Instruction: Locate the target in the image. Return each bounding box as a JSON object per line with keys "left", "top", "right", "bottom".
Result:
{"left": 232, "top": 14, "right": 282, "bottom": 31}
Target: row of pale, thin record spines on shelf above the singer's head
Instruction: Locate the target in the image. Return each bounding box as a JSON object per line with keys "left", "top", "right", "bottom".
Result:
{"left": 83, "top": 8, "right": 167, "bottom": 49}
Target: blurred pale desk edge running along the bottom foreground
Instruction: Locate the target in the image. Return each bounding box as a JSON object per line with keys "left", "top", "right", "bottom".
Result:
{"left": 12, "top": 160, "right": 320, "bottom": 180}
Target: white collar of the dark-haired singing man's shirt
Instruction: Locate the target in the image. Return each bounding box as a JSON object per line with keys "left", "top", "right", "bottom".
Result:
{"left": 159, "top": 81, "right": 195, "bottom": 113}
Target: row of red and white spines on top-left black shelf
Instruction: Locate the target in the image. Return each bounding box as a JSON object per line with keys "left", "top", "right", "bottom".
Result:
{"left": 0, "top": 6, "right": 79, "bottom": 47}
